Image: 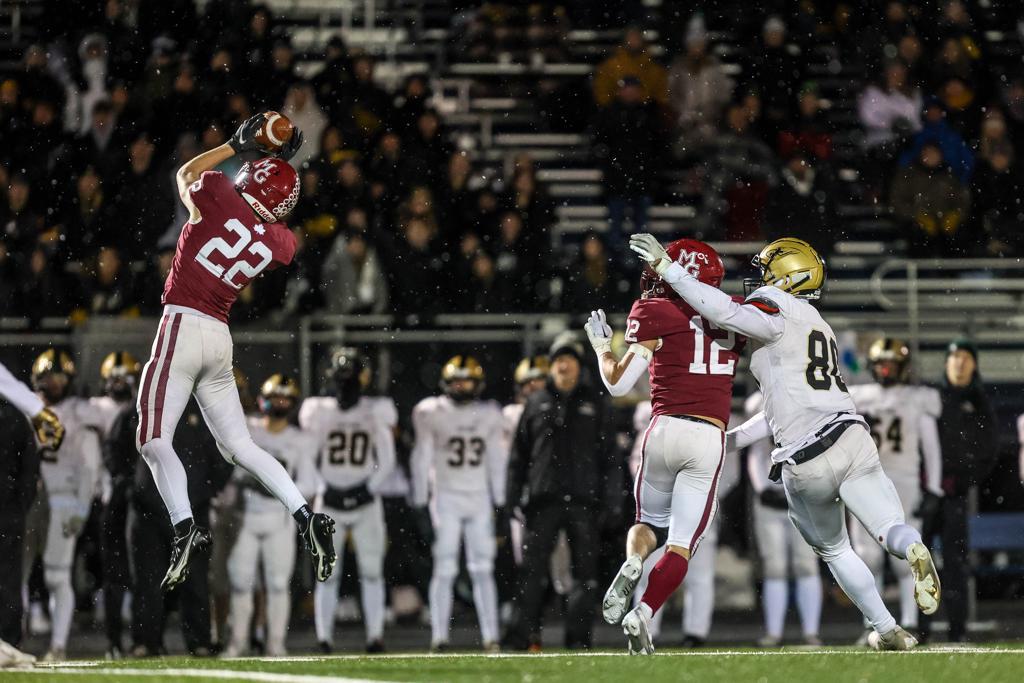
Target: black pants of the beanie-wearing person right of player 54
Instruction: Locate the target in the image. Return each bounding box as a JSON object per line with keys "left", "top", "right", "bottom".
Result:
{"left": 919, "top": 495, "right": 971, "bottom": 642}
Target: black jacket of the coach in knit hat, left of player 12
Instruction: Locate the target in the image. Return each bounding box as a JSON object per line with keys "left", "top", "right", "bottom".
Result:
{"left": 507, "top": 380, "right": 622, "bottom": 510}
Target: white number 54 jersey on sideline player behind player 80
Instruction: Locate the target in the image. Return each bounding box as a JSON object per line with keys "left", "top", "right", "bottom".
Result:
{"left": 850, "top": 384, "right": 942, "bottom": 493}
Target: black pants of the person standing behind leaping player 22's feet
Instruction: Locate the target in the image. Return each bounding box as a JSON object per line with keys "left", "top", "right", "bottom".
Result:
{"left": 131, "top": 508, "right": 211, "bottom": 654}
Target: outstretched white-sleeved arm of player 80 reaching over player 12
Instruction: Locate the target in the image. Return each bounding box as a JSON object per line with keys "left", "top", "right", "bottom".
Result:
{"left": 630, "top": 233, "right": 784, "bottom": 343}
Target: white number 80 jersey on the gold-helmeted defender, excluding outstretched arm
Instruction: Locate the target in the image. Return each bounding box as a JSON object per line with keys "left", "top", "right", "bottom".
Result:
{"left": 746, "top": 287, "right": 862, "bottom": 463}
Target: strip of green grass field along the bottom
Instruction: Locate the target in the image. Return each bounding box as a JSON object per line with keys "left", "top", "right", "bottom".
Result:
{"left": 8, "top": 644, "right": 1024, "bottom": 683}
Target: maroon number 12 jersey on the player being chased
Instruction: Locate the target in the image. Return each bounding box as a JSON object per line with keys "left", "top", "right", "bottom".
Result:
{"left": 626, "top": 298, "right": 746, "bottom": 424}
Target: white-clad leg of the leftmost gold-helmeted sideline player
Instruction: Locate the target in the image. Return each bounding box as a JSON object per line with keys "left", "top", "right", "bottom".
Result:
{"left": 43, "top": 497, "right": 78, "bottom": 659}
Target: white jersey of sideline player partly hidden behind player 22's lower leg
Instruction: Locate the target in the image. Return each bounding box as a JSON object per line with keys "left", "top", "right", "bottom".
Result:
{"left": 238, "top": 417, "right": 319, "bottom": 513}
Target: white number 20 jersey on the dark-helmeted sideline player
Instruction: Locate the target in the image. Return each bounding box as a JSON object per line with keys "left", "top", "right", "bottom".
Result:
{"left": 299, "top": 396, "right": 398, "bottom": 494}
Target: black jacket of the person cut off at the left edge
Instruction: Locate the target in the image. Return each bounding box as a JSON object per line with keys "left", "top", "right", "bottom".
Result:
{"left": 0, "top": 401, "right": 39, "bottom": 511}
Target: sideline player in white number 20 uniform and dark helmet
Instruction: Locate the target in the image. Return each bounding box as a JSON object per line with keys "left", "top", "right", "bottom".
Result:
{"left": 299, "top": 348, "right": 398, "bottom": 652}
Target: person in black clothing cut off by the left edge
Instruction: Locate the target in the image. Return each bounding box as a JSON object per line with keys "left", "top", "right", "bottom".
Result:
{"left": 0, "top": 401, "right": 39, "bottom": 646}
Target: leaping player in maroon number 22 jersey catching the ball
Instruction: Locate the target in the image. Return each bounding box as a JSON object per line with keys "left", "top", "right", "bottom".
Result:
{"left": 137, "top": 114, "right": 335, "bottom": 589}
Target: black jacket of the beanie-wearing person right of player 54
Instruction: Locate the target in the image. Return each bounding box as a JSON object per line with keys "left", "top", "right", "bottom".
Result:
{"left": 938, "top": 374, "right": 997, "bottom": 496}
